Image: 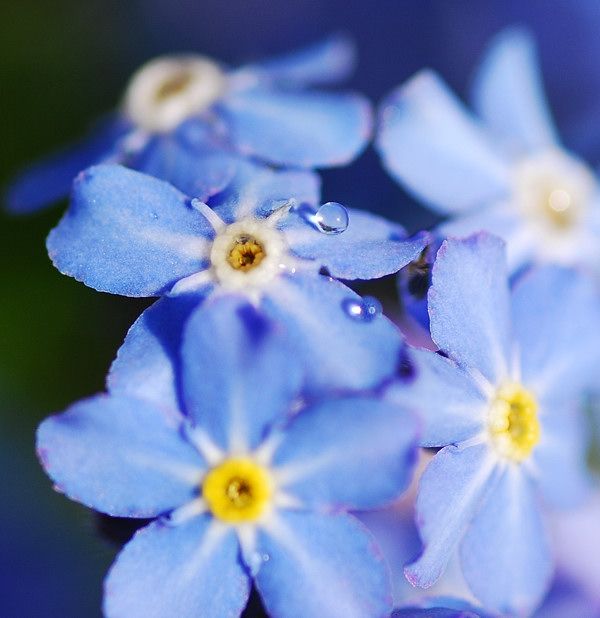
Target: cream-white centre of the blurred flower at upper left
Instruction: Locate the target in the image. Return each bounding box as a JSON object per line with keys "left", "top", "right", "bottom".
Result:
{"left": 124, "top": 56, "right": 226, "bottom": 133}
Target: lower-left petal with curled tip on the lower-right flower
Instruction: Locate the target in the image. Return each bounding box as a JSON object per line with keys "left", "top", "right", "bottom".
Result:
{"left": 405, "top": 444, "right": 497, "bottom": 588}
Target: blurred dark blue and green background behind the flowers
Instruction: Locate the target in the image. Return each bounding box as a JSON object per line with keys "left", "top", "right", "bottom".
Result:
{"left": 0, "top": 0, "right": 600, "bottom": 618}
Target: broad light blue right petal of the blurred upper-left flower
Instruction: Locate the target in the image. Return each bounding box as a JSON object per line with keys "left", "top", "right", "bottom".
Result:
{"left": 222, "top": 89, "right": 371, "bottom": 167}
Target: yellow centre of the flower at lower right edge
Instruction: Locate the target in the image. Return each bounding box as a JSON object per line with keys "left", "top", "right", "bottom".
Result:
{"left": 489, "top": 383, "right": 540, "bottom": 462}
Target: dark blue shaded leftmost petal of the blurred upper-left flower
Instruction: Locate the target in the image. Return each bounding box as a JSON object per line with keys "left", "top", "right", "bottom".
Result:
{"left": 6, "top": 118, "right": 130, "bottom": 214}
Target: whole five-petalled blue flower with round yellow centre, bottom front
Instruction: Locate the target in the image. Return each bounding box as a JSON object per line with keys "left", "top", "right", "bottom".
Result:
{"left": 37, "top": 296, "right": 417, "bottom": 618}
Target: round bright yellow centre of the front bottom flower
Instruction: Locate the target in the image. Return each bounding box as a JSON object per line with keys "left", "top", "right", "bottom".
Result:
{"left": 202, "top": 458, "right": 273, "bottom": 523}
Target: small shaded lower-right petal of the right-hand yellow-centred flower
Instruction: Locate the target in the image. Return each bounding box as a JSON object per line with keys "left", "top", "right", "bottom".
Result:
{"left": 532, "top": 400, "right": 591, "bottom": 508}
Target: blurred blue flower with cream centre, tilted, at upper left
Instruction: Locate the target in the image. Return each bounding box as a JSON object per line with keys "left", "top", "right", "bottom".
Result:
{"left": 7, "top": 37, "right": 371, "bottom": 213}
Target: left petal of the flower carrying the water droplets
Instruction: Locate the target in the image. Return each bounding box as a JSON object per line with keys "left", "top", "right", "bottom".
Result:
{"left": 47, "top": 165, "right": 213, "bottom": 296}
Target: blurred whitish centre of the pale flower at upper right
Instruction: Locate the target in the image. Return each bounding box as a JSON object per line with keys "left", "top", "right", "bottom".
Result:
{"left": 514, "top": 150, "right": 595, "bottom": 235}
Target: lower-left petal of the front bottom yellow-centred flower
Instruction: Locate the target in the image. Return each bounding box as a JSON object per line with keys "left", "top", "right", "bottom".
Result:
{"left": 104, "top": 517, "right": 250, "bottom": 618}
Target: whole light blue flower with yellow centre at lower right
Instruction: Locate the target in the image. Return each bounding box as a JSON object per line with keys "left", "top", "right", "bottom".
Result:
{"left": 390, "top": 233, "right": 600, "bottom": 615}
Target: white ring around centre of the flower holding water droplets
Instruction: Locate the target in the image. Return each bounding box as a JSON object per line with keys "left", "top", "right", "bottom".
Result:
{"left": 210, "top": 219, "right": 288, "bottom": 291}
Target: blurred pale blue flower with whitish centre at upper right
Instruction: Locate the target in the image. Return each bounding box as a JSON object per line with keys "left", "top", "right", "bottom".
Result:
{"left": 377, "top": 29, "right": 600, "bottom": 273}
